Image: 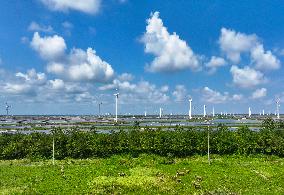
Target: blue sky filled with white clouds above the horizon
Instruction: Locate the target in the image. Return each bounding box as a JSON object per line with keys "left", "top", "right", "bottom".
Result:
{"left": 0, "top": 0, "right": 284, "bottom": 115}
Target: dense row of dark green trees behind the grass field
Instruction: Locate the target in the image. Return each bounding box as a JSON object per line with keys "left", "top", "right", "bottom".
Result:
{"left": 0, "top": 119, "right": 284, "bottom": 159}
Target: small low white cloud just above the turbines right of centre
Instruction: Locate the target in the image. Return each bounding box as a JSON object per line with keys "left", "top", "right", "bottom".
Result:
{"left": 202, "top": 87, "right": 229, "bottom": 104}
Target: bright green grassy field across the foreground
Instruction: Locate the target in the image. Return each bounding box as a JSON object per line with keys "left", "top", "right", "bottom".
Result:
{"left": 0, "top": 154, "right": 284, "bottom": 194}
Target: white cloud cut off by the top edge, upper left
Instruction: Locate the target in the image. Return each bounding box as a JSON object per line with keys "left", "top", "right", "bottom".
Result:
{"left": 41, "top": 0, "right": 101, "bottom": 14}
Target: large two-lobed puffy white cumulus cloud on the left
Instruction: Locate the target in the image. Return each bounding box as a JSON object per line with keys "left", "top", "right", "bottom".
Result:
{"left": 31, "top": 32, "right": 116, "bottom": 82}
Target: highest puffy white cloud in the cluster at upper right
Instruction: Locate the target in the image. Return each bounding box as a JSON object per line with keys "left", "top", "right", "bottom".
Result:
{"left": 219, "top": 28, "right": 257, "bottom": 63}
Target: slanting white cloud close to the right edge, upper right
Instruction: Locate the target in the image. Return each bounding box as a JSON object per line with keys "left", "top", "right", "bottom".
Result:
{"left": 251, "top": 44, "right": 280, "bottom": 70}
